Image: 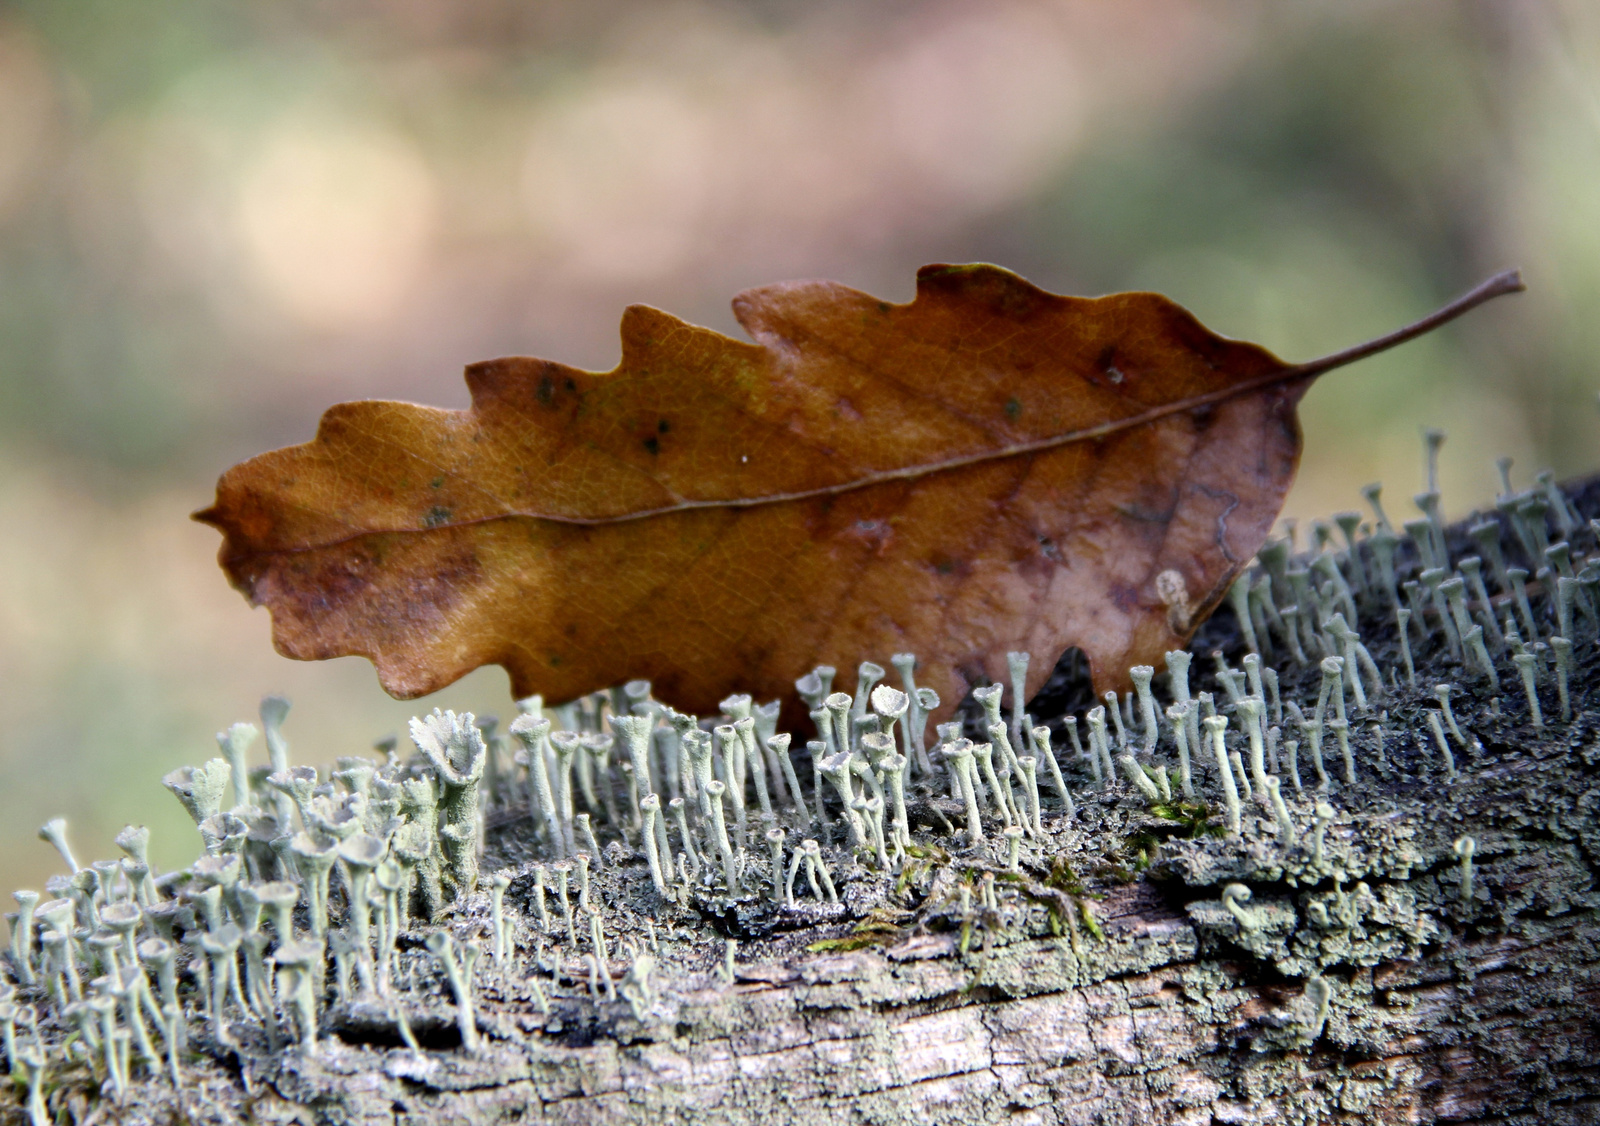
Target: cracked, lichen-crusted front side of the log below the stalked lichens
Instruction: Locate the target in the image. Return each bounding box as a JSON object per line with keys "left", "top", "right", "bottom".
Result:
{"left": 251, "top": 733, "right": 1600, "bottom": 1126}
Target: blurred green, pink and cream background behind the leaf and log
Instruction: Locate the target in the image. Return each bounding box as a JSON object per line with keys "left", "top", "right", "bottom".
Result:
{"left": 0, "top": 0, "right": 1600, "bottom": 886}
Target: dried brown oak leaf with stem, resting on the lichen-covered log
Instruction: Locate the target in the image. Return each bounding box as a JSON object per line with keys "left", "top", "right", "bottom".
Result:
{"left": 195, "top": 266, "right": 1520, "bottom": 713}
